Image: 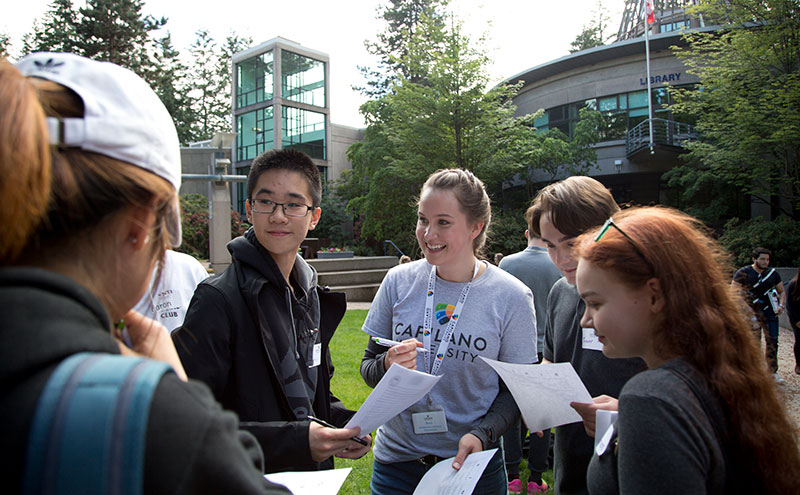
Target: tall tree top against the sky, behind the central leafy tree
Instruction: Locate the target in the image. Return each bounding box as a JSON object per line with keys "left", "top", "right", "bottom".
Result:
{"left": 354, "top": 0, "right": 448, "bottom": 98}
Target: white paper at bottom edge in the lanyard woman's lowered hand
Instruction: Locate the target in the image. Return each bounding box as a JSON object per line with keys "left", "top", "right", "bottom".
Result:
{"left": 414, "top": 449, "right": 497, "bottom": 495}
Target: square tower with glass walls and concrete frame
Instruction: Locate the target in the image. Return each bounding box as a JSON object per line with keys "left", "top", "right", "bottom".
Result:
{"left": 233, "top": 38, "right": 331, "bottom": 212}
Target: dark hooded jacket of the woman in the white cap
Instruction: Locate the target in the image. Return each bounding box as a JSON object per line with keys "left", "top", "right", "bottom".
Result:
{"left": 0, "top": 268, "right": 289, "bottom": 494}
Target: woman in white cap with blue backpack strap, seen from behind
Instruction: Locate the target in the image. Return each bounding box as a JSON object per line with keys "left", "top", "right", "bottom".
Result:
{"left": 0, "top": 53, "right": 288, "bottom": 493}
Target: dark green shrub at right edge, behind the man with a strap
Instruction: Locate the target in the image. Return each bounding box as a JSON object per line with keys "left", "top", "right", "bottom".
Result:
{"left": 716, "top": 215, "right": 800, "bottom": 267}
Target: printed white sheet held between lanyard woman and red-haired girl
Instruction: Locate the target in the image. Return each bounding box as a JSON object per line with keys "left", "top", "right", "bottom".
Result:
{"left": 481, "top": 356, "right": 592, "bottom": 431}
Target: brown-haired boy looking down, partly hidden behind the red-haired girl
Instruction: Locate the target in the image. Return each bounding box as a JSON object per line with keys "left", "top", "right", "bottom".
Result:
{"left": 525, "top": 176, "right": 645, "bottom": 495}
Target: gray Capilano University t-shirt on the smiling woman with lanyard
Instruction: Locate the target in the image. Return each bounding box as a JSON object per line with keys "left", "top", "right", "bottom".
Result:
{"left": 363, "top": 260, "right": 537, "bottom": 463}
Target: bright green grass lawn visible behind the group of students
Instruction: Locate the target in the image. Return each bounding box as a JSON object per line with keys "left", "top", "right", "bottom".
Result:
{"left": 331, "top": 309, "right": 553, "bottom": 495}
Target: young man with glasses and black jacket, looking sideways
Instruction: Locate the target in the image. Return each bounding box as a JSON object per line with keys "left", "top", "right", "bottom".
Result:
{"left": 172, "top": 149, "right": 371, "bottom": 472}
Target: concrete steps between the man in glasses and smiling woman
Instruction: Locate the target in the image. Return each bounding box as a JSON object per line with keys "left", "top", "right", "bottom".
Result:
{"left": 306, "top": 256, "right": 397, "bottom": 302}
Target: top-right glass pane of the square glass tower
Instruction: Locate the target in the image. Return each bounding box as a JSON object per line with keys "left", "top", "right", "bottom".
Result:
{"left": 281, "top": 50, "right": 325, "bottom": 107}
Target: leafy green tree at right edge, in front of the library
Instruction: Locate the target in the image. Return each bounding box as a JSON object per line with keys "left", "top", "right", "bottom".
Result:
{"left": 672, "top": 0, "right": 800, "bottom": 220}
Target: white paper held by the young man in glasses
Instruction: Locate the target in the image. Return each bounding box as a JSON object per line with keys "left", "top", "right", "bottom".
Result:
{"left": 345, "top": 364, "right": 444, "bottom": 436}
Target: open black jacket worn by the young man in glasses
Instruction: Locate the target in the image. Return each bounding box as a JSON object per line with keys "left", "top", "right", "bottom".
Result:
{"left": 172, "top": 229, "right": 353, "bottom": 473}
